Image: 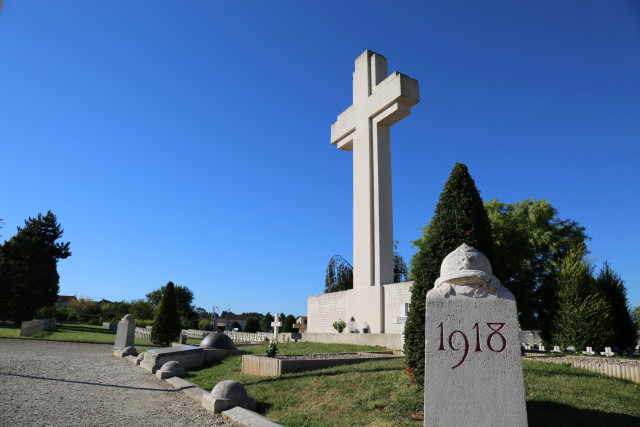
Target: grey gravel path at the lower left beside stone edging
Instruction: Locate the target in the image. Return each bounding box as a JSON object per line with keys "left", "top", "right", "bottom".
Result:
{"left": 0, "top": 338, "right": 236, "bottom": 427}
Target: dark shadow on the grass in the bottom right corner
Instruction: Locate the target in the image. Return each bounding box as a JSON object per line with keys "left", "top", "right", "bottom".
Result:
{"left": 527, "top": 400, "right": 640, "bottom": 427}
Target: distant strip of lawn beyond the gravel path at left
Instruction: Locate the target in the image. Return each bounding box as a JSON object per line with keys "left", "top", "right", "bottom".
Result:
{"left": 0, "top": 323, "right": 152, "bottom": 345}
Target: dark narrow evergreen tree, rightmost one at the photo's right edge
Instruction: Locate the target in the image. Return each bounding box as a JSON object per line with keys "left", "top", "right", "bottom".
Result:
{"left": 595, "top": 262, "right": 638, "bottom": 349}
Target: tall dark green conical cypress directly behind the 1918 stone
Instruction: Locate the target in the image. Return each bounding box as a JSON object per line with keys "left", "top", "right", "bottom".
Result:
{"left": 404, "top": 163, "right": 495, "bottom": 387}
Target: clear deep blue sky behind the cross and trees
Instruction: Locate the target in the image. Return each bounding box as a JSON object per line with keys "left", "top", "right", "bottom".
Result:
{"left": 0, "top": 0, "right": 640, "bottom": 315}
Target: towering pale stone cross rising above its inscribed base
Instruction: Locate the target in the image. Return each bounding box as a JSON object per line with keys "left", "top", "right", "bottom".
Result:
{"left": 331, "top": 50, "right": 420, "bottom": 288}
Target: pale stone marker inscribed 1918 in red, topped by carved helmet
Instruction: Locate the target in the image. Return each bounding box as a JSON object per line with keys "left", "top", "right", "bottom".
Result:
{"left": 424, "top": 244, "right": 527, "bottom": 426}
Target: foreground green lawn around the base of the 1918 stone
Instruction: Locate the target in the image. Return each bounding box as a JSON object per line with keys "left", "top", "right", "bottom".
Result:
{"left": 186, "top": 343, "right": 640, "bottom": 427}
